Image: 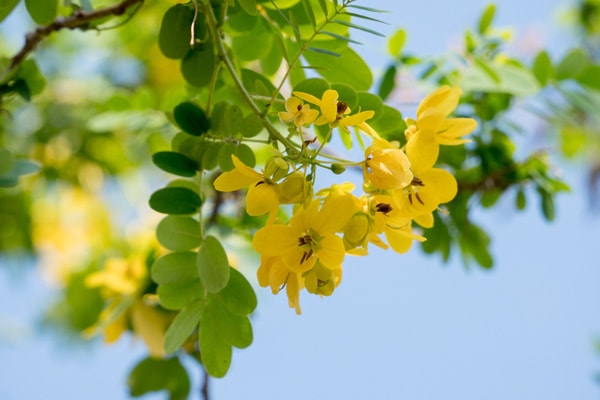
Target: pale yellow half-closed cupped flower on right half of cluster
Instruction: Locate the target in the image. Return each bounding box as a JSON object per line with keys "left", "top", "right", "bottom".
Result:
{"left": 363, "top": 139, "right": 413, "bottom": 190}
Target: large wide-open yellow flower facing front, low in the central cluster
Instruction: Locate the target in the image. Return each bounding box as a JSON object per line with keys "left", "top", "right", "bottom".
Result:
{"left": 253, "top": 196, "right": 354, "bottom": 273}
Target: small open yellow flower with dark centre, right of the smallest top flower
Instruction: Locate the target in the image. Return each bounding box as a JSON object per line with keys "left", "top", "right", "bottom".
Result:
{"left": 294, "top": 89, "right": 375, "bottom": 132}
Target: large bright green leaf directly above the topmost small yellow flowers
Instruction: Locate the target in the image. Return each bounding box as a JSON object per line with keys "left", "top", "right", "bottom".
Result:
{"left": 304, "top": 47, "right": 373, "bottom": 90}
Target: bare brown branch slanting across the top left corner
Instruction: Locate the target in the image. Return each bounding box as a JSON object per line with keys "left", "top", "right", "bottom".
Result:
{"left": 0, "top": 0, "right": 144, "bottom": 80}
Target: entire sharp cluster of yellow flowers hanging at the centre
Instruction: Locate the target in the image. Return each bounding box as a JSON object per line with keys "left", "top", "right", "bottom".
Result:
{"left": 214, "top": 86, "right": 476, "bottom": 314}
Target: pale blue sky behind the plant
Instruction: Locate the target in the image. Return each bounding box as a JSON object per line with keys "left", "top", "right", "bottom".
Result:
{"left": 0, "top": 0, "right": 600, "bottom": 400}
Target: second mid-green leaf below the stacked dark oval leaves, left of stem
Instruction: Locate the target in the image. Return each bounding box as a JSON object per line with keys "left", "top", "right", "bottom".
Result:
{"left": 150, "top": 251, "right": 198, "bottom": 285}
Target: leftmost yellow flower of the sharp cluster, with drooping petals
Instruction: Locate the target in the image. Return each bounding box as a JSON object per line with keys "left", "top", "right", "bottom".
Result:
{"left": 214, "top": 155, "right": 279, "bottom": 216}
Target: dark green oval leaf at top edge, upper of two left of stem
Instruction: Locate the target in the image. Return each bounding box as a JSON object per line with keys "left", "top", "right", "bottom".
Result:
{"left": 158, "top": 4, "right": 194, "bottom": 59}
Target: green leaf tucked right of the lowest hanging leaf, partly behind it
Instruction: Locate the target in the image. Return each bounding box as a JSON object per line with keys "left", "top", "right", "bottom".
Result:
{"left": 206, "top": 301, "right": 253, "bottom": 349}
